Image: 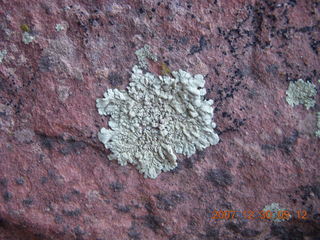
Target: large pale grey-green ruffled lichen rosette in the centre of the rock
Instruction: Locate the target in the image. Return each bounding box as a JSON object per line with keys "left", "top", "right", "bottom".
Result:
{"left": 96, "top": 66, "right": 219, "bottom": 178}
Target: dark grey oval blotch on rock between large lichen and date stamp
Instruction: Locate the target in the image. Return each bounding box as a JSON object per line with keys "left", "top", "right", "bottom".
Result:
{"left": 206, "top": 168, "right": 233, "bottom": 187}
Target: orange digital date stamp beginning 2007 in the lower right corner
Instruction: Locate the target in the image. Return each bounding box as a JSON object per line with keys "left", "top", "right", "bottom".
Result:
{"left": 211, "top": 210, "right": 308, "bottom": 221}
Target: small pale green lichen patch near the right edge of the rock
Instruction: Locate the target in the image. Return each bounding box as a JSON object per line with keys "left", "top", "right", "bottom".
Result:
{"left": 286, "top": 79, "right": 317, "bottom": 109}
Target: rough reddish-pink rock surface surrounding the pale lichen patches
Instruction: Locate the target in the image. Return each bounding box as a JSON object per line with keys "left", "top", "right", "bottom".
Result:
{"left": 0, "top": 0, "right": 320, "bottom": 240}
